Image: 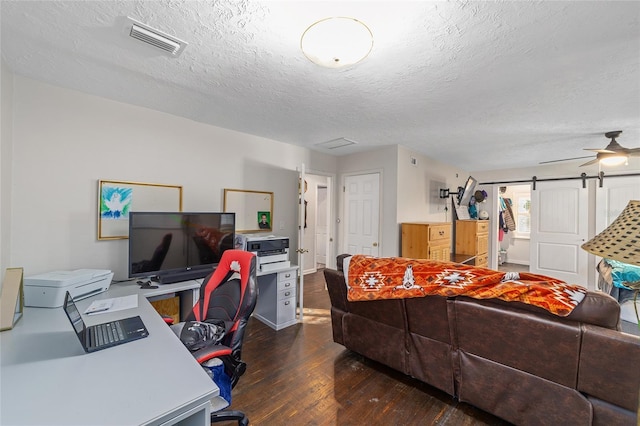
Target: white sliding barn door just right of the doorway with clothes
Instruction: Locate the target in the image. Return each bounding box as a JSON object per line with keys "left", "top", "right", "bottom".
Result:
{"left": 529, "top": 180, "right": 588, "bottom": 287}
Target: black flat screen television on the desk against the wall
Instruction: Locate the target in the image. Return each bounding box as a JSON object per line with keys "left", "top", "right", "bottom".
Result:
{"left": 129, "top": 212, "right": 236, "bottom": 284}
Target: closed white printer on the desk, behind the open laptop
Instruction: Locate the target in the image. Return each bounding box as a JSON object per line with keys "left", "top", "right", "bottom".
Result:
{"left": 24, "top": 269, "right": 113, "bottom": 308}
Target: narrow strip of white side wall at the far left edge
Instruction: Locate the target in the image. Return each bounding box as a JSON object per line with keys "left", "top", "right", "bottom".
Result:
{"left": 0, "top": 61, "right": 13, "bottom": 276}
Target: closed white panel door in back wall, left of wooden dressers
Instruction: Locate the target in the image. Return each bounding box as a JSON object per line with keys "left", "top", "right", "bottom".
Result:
{"left": 344, "top": 173, "right": 380, "bottom": 256}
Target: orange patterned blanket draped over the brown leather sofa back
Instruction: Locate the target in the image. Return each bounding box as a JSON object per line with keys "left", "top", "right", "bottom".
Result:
{"left": 345, "top": 255, "right": 587, "bottom": 317}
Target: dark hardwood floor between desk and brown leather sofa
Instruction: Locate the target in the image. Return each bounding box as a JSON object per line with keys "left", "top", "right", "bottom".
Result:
{"left": 231, "top": 271, "right": 508, "bottom": 426}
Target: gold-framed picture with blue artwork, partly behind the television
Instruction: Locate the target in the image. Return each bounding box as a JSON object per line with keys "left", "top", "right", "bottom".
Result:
{"left": 98, "top": 180, "right": 182, "bottom": 240}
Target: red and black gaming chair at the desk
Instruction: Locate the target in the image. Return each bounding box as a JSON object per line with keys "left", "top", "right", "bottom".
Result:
{"left": 172, "top": 250, "right": 258, "bottom": 425}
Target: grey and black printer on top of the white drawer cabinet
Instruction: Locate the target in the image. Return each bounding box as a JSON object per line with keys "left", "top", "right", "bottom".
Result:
{"left": 237, "top": 234, "right": 291, "bottom": 272}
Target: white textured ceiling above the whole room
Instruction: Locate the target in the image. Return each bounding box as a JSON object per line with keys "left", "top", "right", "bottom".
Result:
{"left": 0, "top": 0, "right": 640, "bottom": 171}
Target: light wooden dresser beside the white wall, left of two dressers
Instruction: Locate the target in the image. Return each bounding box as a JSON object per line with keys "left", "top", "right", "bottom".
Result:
{"left": 400, "top": 222, "right": 451, "bottom": 261}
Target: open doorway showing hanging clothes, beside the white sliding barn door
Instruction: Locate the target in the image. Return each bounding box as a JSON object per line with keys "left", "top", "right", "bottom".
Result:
{"left": 497, "top": 184, "right": 531, "bottom": 272}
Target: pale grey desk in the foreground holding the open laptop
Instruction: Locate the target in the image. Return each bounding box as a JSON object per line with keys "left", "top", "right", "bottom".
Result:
{"left": 0, "top": 289, "right": 219, "bottom": 426}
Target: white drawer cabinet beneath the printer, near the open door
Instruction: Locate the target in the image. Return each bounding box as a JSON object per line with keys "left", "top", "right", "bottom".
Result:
{"left": 253, "top": 266, "right": 298, "bottom": 330}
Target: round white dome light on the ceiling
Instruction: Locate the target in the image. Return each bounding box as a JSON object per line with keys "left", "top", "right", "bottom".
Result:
{"left": 300, "top": 17, "right": 373, "bottom": 68}
